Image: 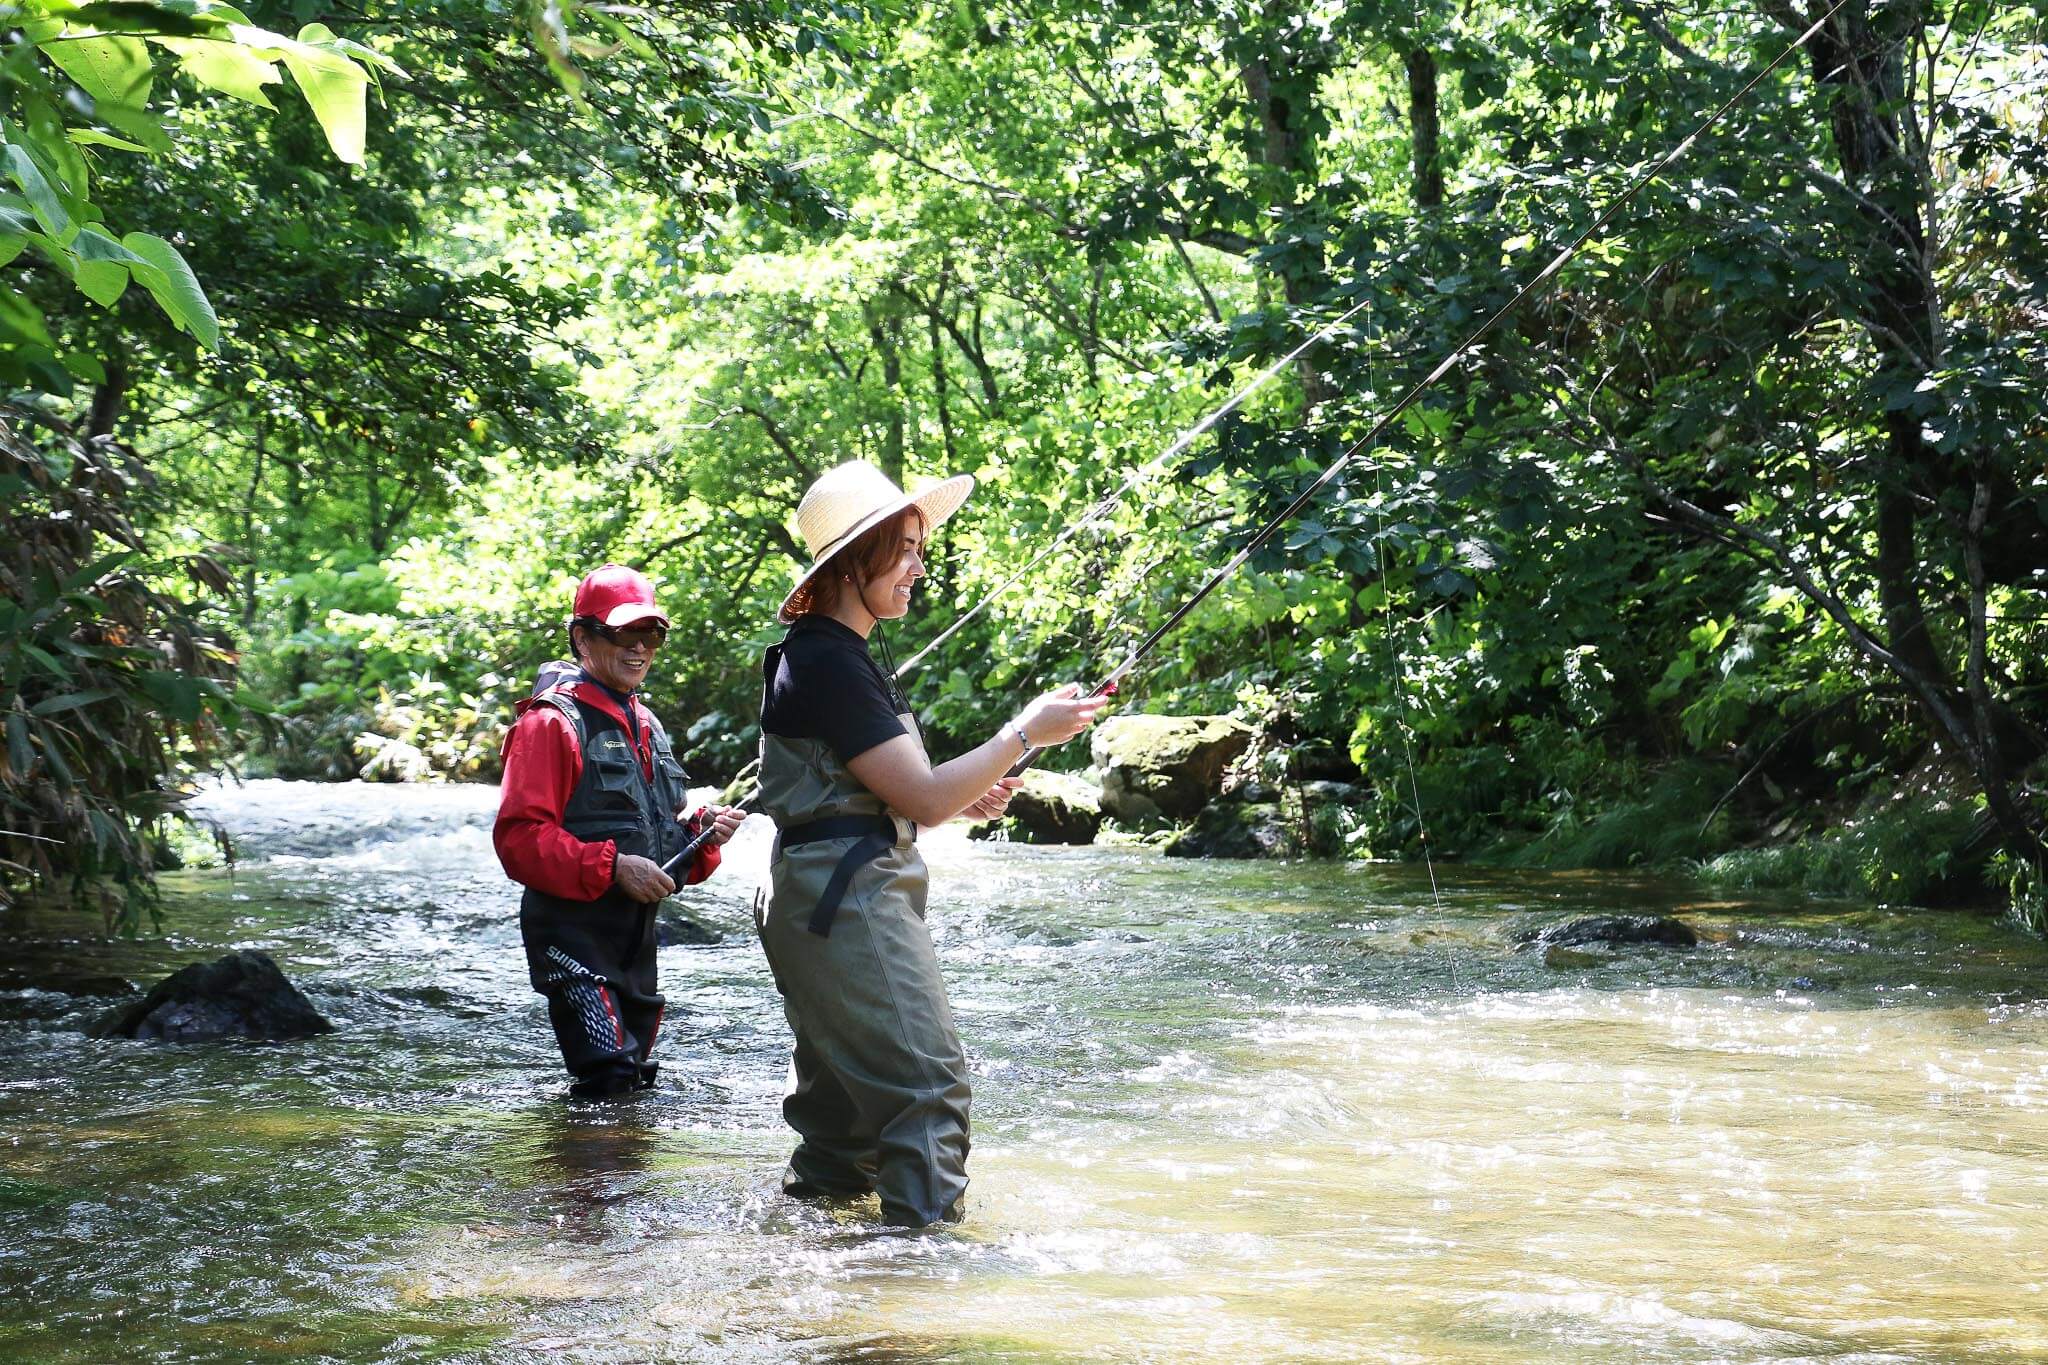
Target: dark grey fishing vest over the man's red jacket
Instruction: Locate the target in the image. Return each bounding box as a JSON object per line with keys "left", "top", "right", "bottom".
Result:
{"left": 526, "top": 688, "right": 690, "bottom": 909}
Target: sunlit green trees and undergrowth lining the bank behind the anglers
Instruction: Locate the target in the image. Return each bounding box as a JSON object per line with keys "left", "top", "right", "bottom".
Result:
{"left": 0, "top": 0, "right": 2048, "bottom": 917}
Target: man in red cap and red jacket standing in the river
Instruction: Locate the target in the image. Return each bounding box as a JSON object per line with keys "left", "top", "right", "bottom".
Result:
{"left": 492, "top": 565, "right": 745, "bottom": 1099}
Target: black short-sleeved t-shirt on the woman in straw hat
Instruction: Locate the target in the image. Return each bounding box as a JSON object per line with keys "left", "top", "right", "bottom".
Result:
{"left": 762, "top": 616, "right": 909, "bottom": 763}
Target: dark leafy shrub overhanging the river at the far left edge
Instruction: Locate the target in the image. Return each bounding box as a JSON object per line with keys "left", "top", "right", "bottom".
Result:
{"left": 0, "top": 417, "right": 246, "bottom": 927}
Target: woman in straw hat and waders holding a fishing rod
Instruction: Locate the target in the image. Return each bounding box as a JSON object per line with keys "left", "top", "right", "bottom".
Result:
{"left": 756, "top": 463, "right": 1102, "bottom": 1228}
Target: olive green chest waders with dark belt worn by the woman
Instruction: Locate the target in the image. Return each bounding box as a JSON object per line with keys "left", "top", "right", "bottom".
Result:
{"left": 754, "top": 716, "right": 967, "bottom": 1228}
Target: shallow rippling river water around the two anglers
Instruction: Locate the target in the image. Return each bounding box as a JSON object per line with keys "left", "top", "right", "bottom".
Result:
{"left": 0, "top": 782, "right": 2048, "bottom": 1363}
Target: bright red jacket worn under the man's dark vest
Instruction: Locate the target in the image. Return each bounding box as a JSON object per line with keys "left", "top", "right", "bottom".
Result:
{"left": 492, "top": 681, "right": 719, "bottom": 900}
